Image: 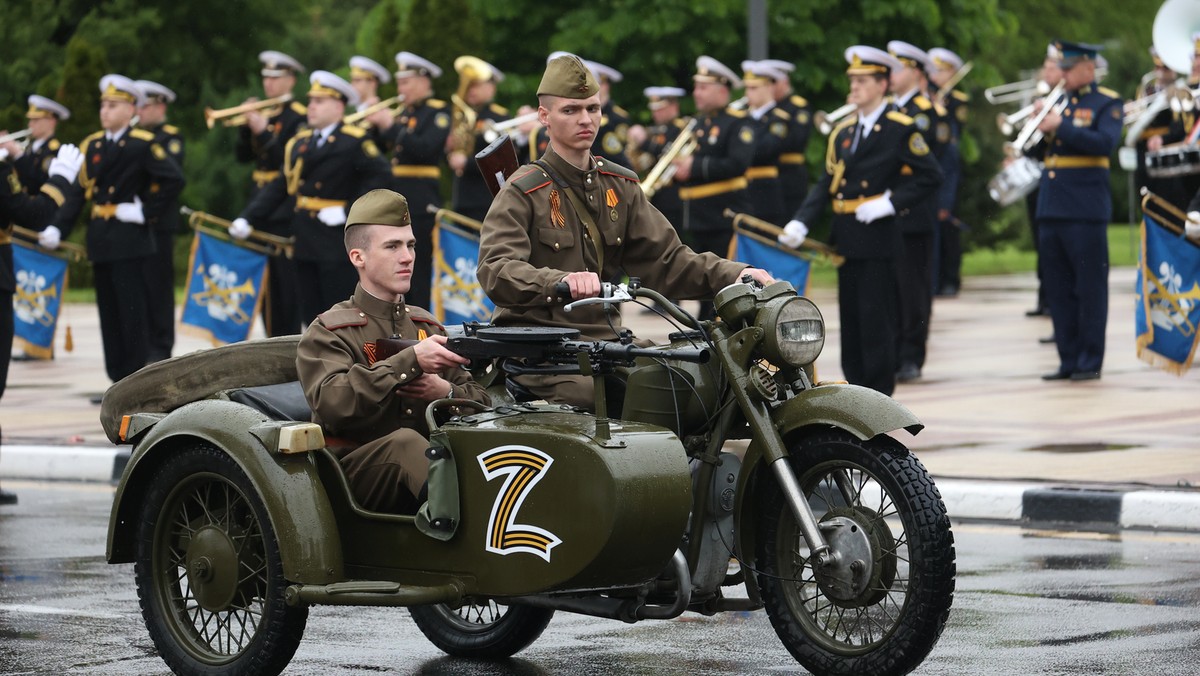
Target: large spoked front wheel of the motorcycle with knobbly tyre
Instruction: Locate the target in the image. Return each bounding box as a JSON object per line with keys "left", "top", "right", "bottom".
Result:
{"left": 757, "top": 431, "right": 955, "bottom": 674}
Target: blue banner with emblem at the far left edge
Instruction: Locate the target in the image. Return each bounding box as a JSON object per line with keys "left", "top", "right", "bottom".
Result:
{"left": 12, "top": 239, "right": 67, "bottom": 359}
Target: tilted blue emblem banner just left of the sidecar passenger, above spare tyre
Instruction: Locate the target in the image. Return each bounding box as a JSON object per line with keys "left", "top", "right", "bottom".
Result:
{"left": 179, "top": 231, "right": 266, "bottom": 346}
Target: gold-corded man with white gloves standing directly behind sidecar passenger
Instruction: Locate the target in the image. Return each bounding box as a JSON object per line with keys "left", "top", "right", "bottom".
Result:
{"left": 236, "top": 71, "right": 391, "bottom": 323}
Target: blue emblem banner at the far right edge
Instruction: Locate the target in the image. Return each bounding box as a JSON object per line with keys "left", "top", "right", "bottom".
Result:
{"left": 1134, "top": 215, "right": 1200, "bottom": 375}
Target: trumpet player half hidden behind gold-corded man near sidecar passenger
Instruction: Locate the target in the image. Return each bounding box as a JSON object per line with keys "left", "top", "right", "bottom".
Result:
{"left": 234, "top": 49, "right": 307, "bottom": 336}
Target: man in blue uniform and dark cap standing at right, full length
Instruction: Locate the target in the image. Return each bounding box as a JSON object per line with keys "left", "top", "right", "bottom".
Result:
{"left": 1037, "top": 41, "right": 1124, "bottom": 381}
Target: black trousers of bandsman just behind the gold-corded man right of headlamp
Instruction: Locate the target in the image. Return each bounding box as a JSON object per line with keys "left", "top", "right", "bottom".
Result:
{"left": 896, "top": 232, "right": 935, "bottom": 369}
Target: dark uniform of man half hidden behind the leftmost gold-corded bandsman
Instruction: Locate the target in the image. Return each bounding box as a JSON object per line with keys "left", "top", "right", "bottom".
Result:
{"left": 138, "top": 125, "right": 184, "bottom": 361}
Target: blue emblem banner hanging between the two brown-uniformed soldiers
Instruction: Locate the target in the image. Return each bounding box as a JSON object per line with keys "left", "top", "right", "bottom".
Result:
{"left": 430, "top": 217, "right": 496, "bottom": 325}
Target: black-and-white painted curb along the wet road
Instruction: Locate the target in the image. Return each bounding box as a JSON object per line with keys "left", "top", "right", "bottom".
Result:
{"left": 0, "top": 444, "right": 1200, "bottom": 532}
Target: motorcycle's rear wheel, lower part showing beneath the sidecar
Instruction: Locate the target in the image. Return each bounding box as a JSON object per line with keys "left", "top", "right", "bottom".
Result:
{"left": 409, "top": 600, "right": 554, "bottom": 659}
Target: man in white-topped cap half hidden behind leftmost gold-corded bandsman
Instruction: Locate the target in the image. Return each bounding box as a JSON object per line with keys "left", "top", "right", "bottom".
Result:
{"left": 137, "top": 79, "right": 184, "bottom": 361}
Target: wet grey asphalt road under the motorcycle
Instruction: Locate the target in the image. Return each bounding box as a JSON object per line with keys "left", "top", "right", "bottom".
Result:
{"left": 0, "top": 481, "right": 1200, "bottom": 676}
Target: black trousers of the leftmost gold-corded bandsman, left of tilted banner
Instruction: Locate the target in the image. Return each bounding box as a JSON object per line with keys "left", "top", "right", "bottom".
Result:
{"left": 92, "top": 256, "right": 150, "bottom": 383}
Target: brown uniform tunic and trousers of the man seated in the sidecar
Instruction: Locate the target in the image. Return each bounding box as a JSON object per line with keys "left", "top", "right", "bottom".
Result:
{"left": 296, "top": 286, "right": 488, "bottom": 513}
